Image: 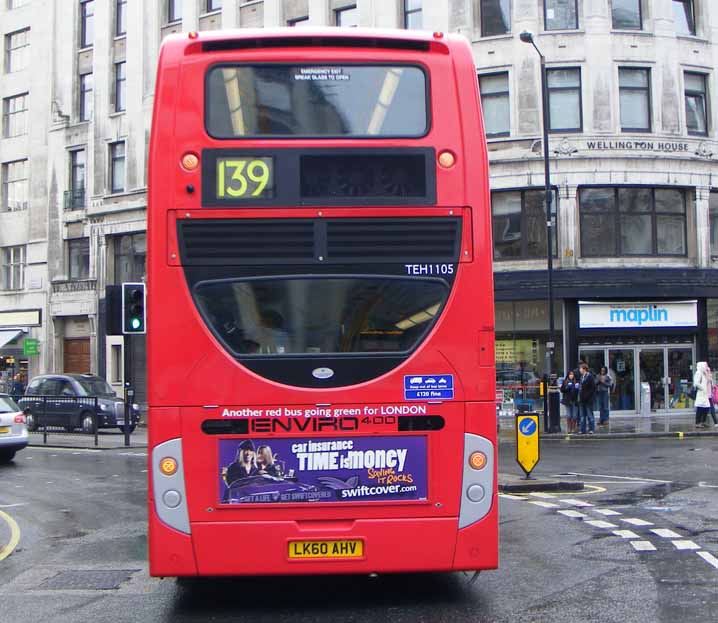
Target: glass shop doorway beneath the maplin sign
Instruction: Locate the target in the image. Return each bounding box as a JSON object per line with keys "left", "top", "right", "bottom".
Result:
{"left": 579, "top": 344, "right": 695, "bottom": 414}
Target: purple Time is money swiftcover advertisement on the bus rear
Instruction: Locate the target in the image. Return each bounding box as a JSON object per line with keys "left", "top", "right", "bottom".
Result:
{"left": 219, "top": 436, "right": 427, "bottom": 504}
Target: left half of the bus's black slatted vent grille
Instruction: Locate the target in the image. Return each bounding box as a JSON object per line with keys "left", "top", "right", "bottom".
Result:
{"left": 178, "top": 219, "right": 315, "bottom": 266}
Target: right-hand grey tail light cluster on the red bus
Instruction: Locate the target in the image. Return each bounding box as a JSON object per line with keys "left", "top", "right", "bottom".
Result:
{"left": 459, "top": 433, "right": 494, "bottom": 529}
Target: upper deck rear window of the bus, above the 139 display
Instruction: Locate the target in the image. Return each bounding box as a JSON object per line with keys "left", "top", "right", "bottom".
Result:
{"left": 205, "top": 64, "right": 429, "bottom": 139}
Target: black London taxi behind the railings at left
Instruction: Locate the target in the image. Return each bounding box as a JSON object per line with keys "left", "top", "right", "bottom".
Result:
{"left": 18, "top": 374, "right": 140, "bottom": 434}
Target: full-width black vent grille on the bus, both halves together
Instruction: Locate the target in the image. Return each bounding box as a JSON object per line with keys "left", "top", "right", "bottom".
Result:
{"left": 178, "top": 217, "right": 461, "bottom": 266}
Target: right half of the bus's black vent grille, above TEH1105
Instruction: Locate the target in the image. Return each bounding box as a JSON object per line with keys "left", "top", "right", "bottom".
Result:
{"left": 327, "top": 217, "right": 461, "bottom": 263}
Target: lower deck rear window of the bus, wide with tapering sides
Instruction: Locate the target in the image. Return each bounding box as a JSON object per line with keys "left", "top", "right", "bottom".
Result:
{"left": 194, "top": 276, "right": 449, "bottom": 356}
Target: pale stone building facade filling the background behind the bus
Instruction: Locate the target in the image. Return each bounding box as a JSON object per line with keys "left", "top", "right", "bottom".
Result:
{"left": 0, "top": 0, "right": 718, "bottom": 420}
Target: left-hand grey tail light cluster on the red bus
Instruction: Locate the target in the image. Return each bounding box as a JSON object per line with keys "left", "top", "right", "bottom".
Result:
{"left": 152, "top": 439, "right": 192, "bottom": 534}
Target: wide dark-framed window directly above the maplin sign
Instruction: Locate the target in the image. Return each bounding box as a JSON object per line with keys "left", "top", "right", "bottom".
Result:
{"left": 579, "top": 186, "right": 687, "bottom": 257}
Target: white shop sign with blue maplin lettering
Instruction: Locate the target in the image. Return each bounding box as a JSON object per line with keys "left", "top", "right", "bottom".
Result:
{"left": 578, "top": 301, "right": 698, "bottom": 329}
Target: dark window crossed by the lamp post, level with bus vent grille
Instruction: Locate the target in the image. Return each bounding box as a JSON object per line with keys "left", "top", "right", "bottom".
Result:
{"left": 491, "top": 190, "right": 558, "bottom": 260}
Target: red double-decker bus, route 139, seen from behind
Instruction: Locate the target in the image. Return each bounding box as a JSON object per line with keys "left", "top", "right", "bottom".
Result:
{"left": 147, "top": 29, "right": 498, "bottom": 576}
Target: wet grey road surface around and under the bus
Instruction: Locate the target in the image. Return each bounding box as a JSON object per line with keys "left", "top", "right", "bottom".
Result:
{"left": 0, "top": 439, "right": 718, "bottom": 623}
